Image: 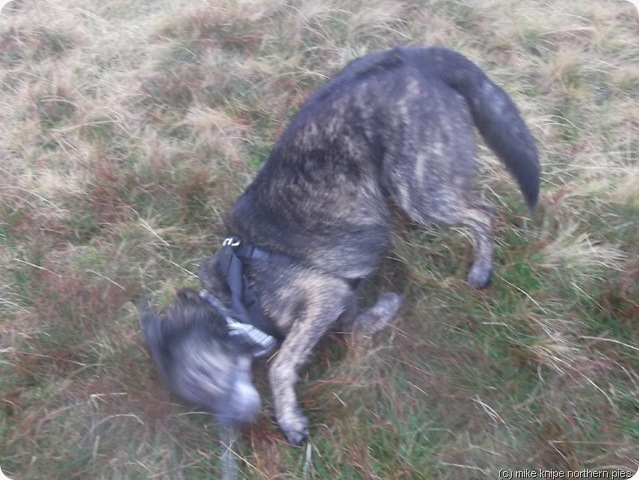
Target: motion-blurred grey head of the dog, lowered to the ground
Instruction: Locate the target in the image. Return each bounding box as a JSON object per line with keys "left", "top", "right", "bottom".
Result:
{"left": 139, "top": 289, "right": 260, "bottom": 427}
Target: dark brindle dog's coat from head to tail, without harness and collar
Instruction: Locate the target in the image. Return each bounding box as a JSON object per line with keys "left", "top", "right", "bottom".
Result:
{"left": 143, "top": 48, "right": 540, "bottom": 445}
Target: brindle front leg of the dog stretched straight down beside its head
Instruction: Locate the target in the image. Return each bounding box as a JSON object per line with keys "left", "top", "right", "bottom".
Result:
{"left": 269, "top": 294, "right": 347, "bottom": 446}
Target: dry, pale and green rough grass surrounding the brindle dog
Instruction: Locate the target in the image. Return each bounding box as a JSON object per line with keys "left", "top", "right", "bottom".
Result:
{"left": 0, "top": 0, "right": 639, "bottom": 480}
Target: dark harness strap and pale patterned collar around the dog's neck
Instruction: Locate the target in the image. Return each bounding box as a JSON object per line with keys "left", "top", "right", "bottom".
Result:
{"left": 200, "top": 237, "right": 282, "bottom": 358}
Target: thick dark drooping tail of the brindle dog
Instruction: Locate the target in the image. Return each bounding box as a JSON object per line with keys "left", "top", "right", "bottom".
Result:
{"left": 409, "top": 47, "right": 540, "bottom": 210}
